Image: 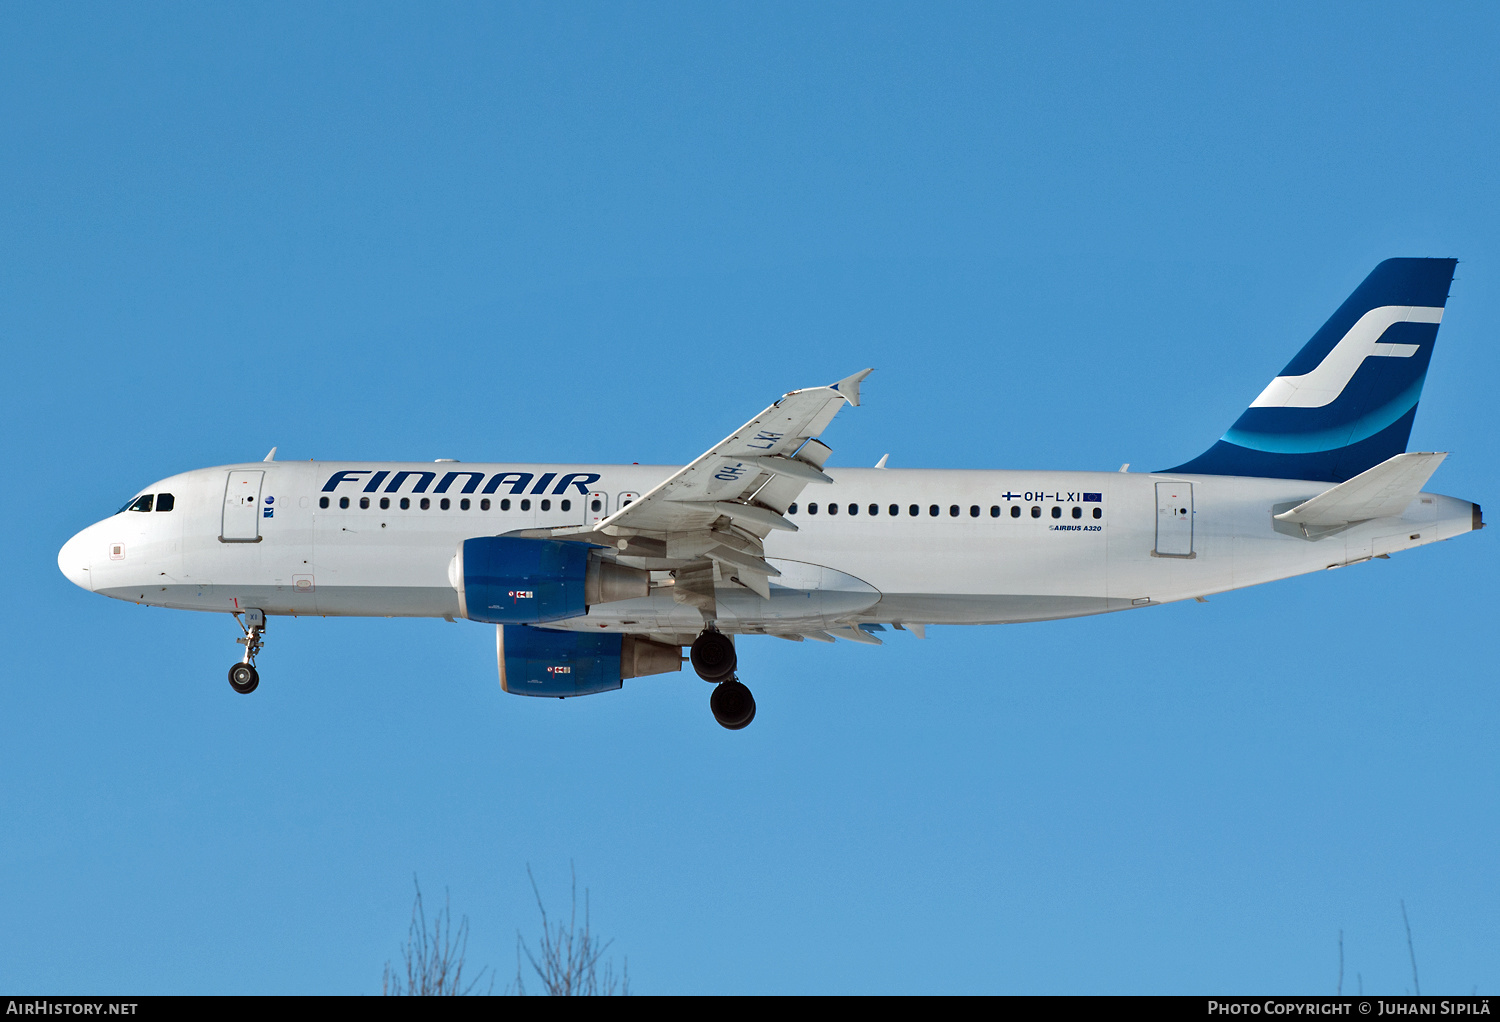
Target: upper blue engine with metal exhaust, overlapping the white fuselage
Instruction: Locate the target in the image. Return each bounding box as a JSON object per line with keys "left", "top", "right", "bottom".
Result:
{"left": 449, "top": 536, "right": 651, "bottom": 624}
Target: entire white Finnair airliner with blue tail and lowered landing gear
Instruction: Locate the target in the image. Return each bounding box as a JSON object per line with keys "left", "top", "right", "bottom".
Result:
{"left": 57, "top": 260, "right": 1484, "bottom": 729}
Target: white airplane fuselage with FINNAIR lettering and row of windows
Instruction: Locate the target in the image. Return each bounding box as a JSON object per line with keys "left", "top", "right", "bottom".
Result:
{"left": 59, "top": 462, "right": 1479, "bottom": 635}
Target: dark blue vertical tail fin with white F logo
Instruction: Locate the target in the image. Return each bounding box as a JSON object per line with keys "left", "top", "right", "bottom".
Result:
{"left": 1166, "top": 253, "right": 1457, "bottom": 483}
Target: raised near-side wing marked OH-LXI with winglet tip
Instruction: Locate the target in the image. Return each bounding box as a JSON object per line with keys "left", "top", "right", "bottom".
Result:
{"left": 594, "top": 369, "right": 873, "bottom": 539}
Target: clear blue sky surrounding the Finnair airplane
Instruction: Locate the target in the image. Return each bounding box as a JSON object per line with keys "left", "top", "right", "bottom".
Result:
{"left": 0, "top": 3, "right": 1500, "bottom": 993}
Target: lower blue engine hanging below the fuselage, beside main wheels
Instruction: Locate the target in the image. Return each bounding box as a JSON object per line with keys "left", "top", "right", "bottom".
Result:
{"left": 495, "top": 624, "right": 683, "bottom": 699}
